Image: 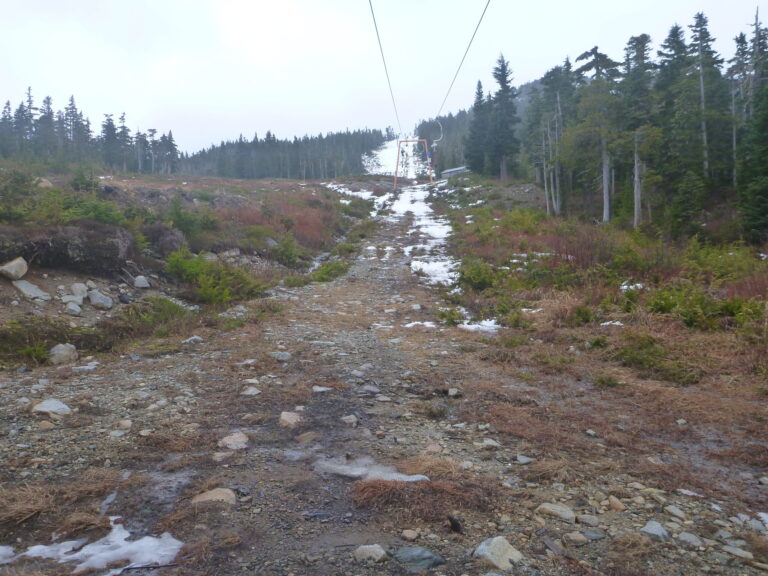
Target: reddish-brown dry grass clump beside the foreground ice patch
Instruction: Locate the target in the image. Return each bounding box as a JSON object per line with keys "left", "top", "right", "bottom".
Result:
{"left": 352, "top": 480, "right": 493, "bottom": 521}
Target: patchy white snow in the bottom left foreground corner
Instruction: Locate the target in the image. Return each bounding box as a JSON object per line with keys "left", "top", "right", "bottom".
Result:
{"left": 6, "top": 517, "right": 183, "bottom": 576}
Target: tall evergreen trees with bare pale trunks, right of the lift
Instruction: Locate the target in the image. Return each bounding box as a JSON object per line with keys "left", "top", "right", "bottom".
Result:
{"left": 419, "top": 13, "right": 768, "bottom": 241}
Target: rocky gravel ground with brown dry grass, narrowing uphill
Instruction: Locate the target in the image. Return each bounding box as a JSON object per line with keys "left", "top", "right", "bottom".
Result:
{"left": 0, "top": 186, "right": 768, "bottom": 576}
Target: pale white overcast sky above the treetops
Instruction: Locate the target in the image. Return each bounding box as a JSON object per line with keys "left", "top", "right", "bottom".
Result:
{"left": 0, "top": 0, "right": 768, "bottom": 152}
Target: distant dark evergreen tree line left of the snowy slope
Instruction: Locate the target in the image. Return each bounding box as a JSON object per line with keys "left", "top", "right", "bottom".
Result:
{"left": 0, "top": 88, "right": 384, "bottom": 179}
